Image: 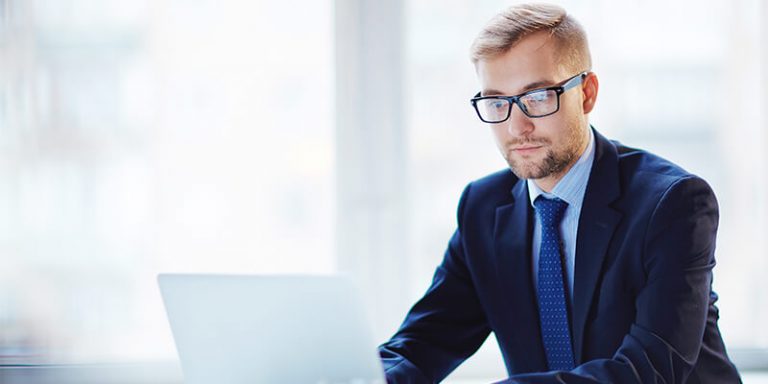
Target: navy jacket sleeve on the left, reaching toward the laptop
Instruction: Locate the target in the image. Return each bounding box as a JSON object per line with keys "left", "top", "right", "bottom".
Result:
{"left": 379, "top": 185, "right": 490, "bottom": 384}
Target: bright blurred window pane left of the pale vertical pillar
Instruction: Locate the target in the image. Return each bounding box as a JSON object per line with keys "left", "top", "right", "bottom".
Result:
{"left": 0, "top": 0, "right": 335, "bottom": 363}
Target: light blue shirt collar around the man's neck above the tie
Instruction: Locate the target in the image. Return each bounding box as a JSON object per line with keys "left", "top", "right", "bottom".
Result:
{"left": 526, "top": 129, "right": 595, "bottom": 210}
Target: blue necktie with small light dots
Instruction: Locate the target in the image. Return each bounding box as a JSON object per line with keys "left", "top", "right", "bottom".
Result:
{"left": 533, "top": 196, "right": 574, "bottom": 371}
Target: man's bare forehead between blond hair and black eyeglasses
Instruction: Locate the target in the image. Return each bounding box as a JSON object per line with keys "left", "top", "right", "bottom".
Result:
{"left": 476, "top": 32, "right": 565, "bottom": 95}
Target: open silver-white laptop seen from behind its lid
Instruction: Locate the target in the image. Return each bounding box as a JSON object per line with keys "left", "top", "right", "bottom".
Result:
{"left": 158, "top": 274, "right": 385, "bottom": 384}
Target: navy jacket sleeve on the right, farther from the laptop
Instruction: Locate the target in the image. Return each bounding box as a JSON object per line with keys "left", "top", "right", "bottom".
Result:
{"left": 504, "top": 177, "right": 718, "bottom": 384}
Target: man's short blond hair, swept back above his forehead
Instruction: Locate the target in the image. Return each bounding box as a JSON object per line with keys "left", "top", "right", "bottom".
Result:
{"left": 470, "top": 4, "right": 592, "bottom": 71}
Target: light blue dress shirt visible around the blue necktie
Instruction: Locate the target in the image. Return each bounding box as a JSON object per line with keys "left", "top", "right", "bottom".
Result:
{"left": 527, "top": 129, "right": 595, "bottom": 301}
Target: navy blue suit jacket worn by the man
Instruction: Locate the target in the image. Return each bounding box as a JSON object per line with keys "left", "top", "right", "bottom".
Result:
{"left": 380, "top": 131, "right": 740, "bottom": 383}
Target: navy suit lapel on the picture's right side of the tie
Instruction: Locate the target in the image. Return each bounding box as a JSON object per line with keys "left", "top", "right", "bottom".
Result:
{"left": 573, "top": 131, "right": 621, "bottom": 364}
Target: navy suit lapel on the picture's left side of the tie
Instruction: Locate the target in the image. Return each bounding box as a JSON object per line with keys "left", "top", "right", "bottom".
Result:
{"left": 494, "top": 180, "right": 547, "bottom": 372}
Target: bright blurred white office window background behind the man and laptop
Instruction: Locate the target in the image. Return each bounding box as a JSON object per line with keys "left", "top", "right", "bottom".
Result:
{"left": 0, "top": 0, "right": 768, "bottom": 380}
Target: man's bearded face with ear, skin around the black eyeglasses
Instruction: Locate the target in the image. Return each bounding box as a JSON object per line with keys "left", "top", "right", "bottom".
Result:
{"left": 476, "top": 33, "right": 596, "bottom": 191}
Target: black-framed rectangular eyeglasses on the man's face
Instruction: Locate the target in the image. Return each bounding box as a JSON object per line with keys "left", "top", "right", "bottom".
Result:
{"left": 470, "top": 72, "right": 587, "bottom": 124}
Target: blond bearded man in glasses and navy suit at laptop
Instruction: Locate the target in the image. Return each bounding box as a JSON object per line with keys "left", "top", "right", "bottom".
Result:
{"left": 380, "top": 5, "right": 740, "bottom": 383}
